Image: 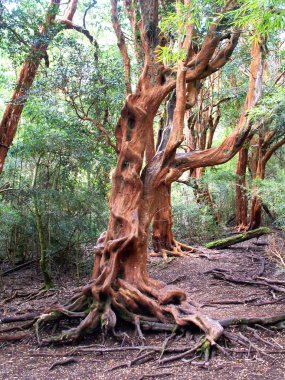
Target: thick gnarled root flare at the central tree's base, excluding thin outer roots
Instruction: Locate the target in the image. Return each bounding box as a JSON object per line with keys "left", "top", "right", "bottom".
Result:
{"left": 35, "top": 279, "right": 223, "bottom": 345}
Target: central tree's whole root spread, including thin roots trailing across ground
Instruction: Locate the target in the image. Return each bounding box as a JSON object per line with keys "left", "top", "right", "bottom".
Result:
{"left": 28, "top": 279, "right": 285, "bottom": 370}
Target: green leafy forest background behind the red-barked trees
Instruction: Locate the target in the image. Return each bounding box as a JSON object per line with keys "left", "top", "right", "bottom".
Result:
{"left": 0, "top": 0, "right": 285, "bottom": 288}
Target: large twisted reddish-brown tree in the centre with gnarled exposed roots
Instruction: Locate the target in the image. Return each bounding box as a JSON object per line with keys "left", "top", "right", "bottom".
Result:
{"left": 37, "top": 0, "right": 255, "bottom": 343}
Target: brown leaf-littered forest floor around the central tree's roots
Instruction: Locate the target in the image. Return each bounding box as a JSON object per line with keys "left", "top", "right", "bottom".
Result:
{"left": 0, "top": 236, "right": 285, "bottom": 380}
